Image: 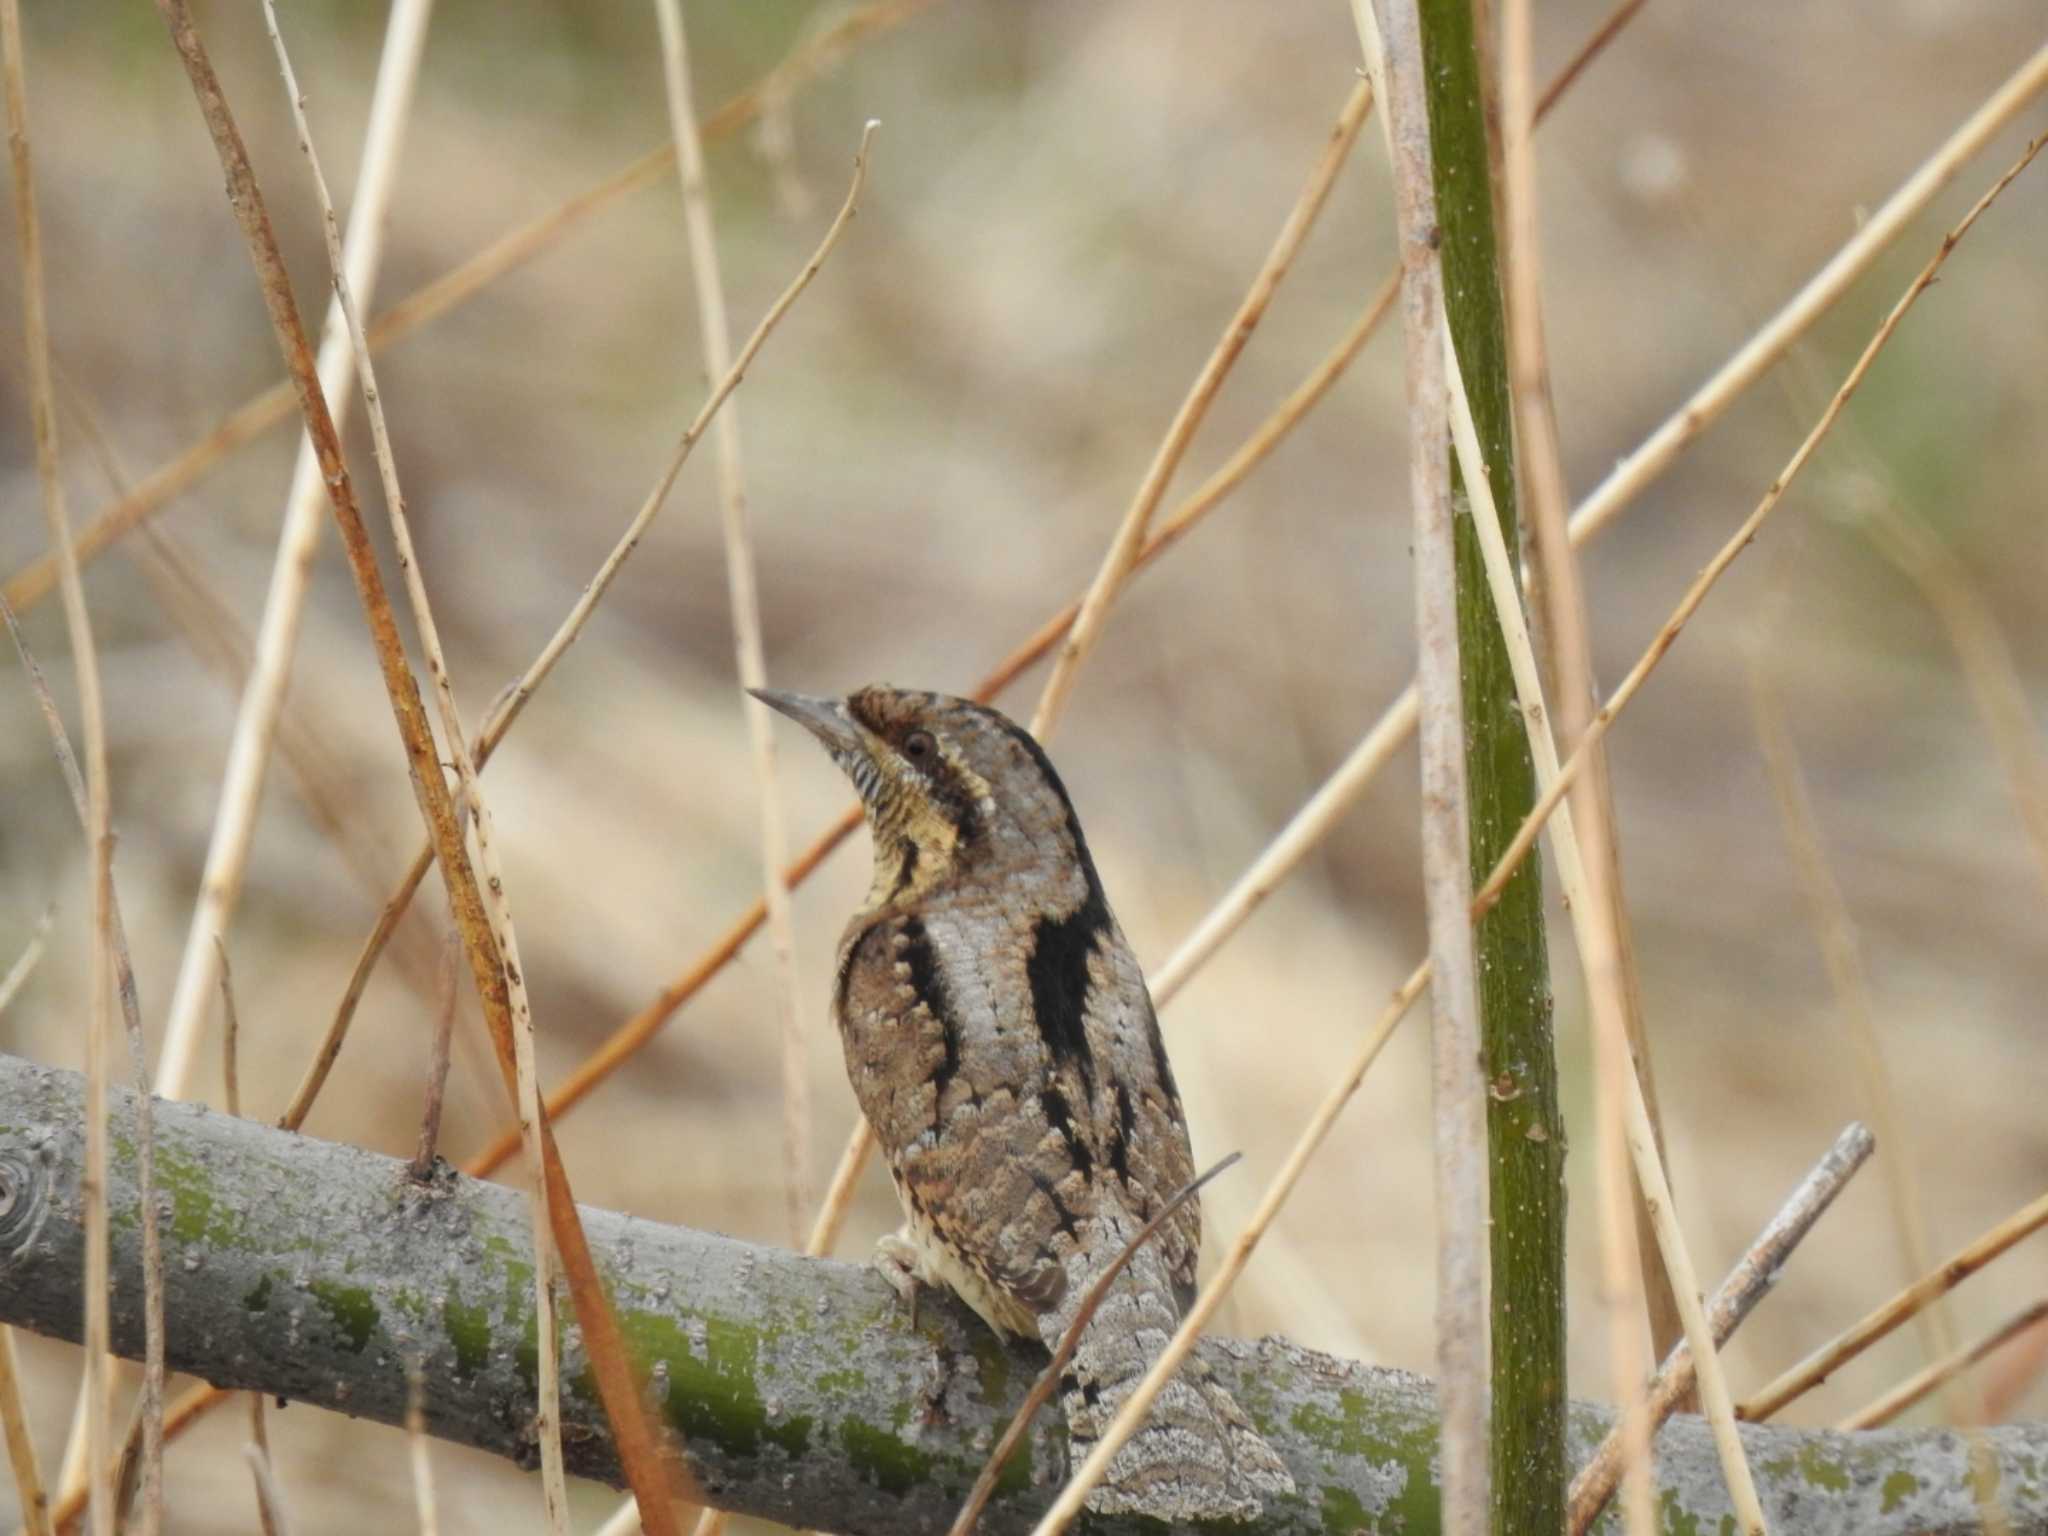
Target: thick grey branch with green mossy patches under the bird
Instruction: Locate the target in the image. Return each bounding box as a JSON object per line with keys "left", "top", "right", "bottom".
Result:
{"left": 0, "top": 1057, "right": 2048, "bottom": 1536}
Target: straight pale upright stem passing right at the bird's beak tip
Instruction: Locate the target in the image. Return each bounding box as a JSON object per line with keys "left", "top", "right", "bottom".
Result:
{"left": 653, "top": 0, "right": 819, "bottom": 1241}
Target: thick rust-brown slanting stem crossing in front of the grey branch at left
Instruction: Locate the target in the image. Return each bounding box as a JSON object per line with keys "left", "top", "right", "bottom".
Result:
{"left": 158, "top": 0, "right": 688, "bottom": 1531}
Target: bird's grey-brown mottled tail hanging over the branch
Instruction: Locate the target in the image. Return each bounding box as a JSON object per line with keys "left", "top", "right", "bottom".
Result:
{"left": 1040, "top": 1253, "right": 1294, "bottom": 1522}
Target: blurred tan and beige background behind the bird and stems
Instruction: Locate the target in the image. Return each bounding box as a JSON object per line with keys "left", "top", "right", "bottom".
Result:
{"left": 0, "top": 0, "right": 2048, "bottom": 1532}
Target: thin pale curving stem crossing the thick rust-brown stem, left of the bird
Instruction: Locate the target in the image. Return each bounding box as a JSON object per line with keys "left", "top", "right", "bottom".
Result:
{"left": 262, "top": 0, "right": 577, "bottom": 1536}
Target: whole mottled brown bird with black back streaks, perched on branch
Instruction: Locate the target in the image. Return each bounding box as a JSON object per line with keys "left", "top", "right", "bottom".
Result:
{"left": 760, "top": 688, "right": 1294, "bottom": 1520}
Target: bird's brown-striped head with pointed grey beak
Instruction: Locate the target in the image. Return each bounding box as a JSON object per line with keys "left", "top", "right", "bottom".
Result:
{"left": 754, "top": 686, "right": 1094, "bottom": 905}
